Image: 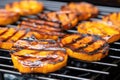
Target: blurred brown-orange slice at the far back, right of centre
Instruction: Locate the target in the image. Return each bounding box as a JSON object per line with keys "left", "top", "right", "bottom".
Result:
{"left": 61, "top": 2, "right": 99, "bottom": 21}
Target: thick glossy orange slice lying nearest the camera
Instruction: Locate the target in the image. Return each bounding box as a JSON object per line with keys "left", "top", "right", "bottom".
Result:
{"left": 11, "top": 49, "right": 67, "bottom": 74}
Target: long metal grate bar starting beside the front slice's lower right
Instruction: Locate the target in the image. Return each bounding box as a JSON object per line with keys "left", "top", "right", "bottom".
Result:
{"left": 66, "top": 66, "right": 109, "bottom": 75}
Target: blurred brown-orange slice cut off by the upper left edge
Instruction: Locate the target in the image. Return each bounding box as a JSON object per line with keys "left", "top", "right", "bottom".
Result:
{"left": 0, "top": 9, "right": 20, "bottom": 26}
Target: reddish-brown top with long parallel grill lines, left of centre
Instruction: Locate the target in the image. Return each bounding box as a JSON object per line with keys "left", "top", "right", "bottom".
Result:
{"left": 18, "top": 19, "right": 64, "bottom": 36}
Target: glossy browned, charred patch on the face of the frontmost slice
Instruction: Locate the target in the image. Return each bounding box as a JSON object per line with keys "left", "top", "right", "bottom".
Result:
{"left": 13, "top": 51, "right": 64, "bottom": 67}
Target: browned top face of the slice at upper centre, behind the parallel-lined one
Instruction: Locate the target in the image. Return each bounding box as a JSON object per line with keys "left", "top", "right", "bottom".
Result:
{"left": 39, "top": 11, "right": 76, "bottom": 27}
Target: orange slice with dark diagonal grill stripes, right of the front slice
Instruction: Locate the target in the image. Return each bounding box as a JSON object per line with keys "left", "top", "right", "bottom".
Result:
{"left": 60, "top": 34, "right": 109, "bottom": 62}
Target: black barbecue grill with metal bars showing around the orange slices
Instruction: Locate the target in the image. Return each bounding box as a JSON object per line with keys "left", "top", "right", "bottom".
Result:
{"left": 0, "top": 0, "right": 120, "bottom": 80}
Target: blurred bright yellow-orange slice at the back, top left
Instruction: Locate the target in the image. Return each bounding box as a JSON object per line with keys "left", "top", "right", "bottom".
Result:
{"left": 5, "top": 0, "right": 43, "bottom": 16}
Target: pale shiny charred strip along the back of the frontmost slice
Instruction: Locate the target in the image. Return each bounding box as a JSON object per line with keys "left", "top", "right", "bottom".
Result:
{"left": 14, "top": 39, "right": 65, "bottom": 51}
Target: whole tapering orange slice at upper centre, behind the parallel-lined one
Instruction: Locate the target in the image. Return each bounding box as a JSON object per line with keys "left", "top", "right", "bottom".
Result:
{"left": 38, "top": 11, "right": 78, "bottom": 30}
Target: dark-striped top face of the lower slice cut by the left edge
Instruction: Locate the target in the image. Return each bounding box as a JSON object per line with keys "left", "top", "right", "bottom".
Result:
{"left": 0, "top": 28, "right": 33, "bottom": 42}
